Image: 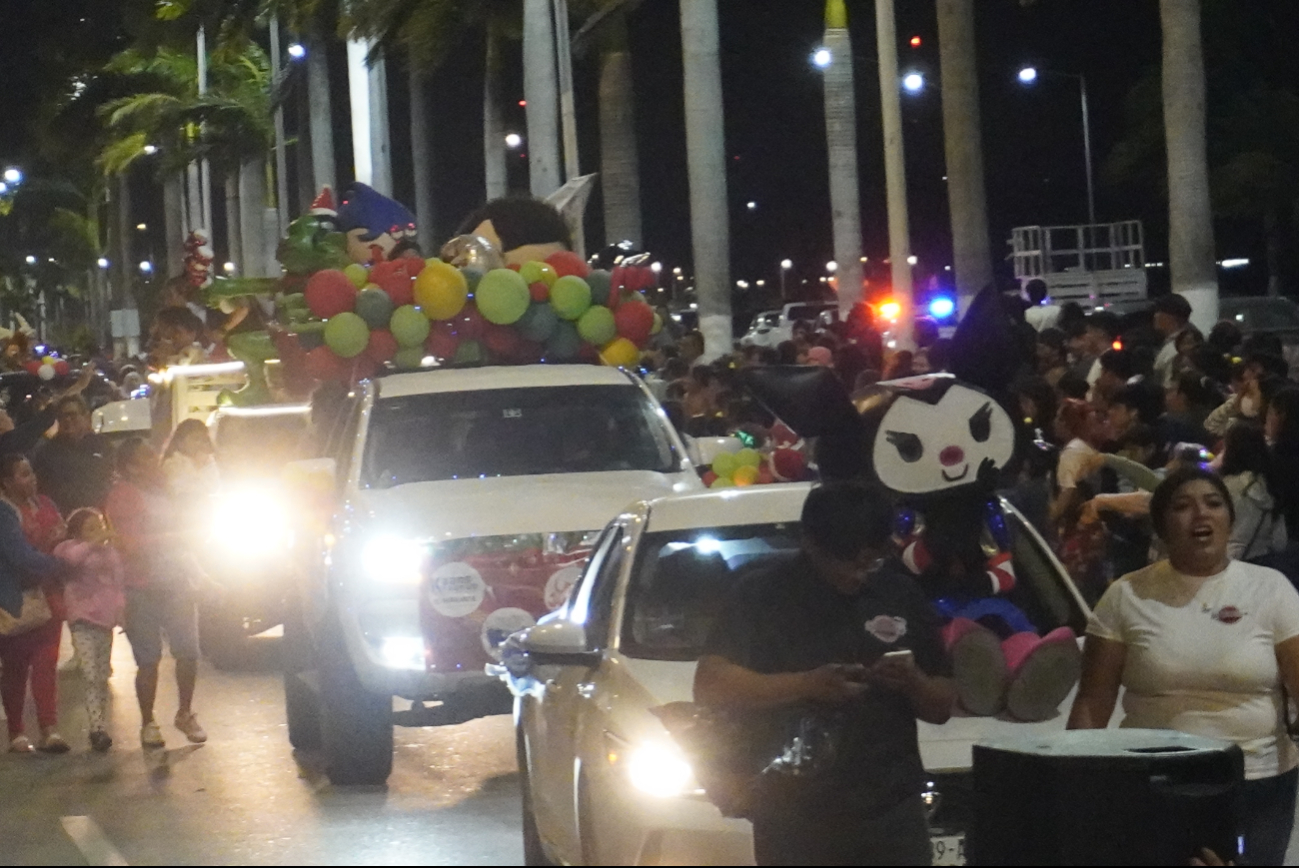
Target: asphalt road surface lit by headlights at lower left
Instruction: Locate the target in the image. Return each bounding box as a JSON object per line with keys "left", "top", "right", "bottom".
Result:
{"left": 0, "top": 626, "right": 522, "bottom": 865}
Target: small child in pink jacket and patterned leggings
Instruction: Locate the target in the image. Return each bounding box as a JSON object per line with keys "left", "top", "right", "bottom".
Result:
{"left": 55, "top": 508, "right": 126, "bottom": 752}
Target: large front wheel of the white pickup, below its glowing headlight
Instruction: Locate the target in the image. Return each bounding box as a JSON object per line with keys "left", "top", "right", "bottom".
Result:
{"left": 320, "top": 634, "right": 392, "bottom": 786}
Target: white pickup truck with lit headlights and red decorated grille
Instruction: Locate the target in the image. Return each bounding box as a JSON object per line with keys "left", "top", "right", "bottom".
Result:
{"left": 284, "top": 365, "right": 703, "bottom": 784}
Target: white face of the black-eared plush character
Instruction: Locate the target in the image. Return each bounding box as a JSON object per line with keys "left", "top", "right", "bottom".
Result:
{"left": 873, "top": 378, "right": 1015, "bottom": 494}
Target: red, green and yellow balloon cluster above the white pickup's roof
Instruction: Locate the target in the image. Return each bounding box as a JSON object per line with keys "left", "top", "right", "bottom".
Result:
{"left": 289, "top": 239, "right": 662, "bottom": 381}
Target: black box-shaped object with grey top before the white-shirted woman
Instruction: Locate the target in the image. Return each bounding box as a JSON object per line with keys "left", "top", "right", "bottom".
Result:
{"left": 965, "top": 729, "right": 1244, "bottom": 865}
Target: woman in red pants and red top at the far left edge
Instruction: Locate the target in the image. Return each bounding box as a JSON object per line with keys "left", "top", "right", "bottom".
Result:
{"left": 0, "top": 455, "right": 68, "bottom": 754}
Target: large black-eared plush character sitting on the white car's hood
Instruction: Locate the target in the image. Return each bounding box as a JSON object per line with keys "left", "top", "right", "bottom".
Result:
{"left": 743, "top": 290, "right": 1081, "bottom": 721}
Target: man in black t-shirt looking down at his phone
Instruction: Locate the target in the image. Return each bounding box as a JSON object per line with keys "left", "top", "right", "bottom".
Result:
{"left": 695, "top": 483, "right": 956, "bottom": 865}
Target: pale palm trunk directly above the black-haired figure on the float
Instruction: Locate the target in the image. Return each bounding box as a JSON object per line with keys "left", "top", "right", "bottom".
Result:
{"left": 523, "top": 0, "right": 560, "bottom": 199}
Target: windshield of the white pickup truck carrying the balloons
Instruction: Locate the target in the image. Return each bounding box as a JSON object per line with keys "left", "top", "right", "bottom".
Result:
{"left": 361, "top": 386, "right": 681, "bottom": 489}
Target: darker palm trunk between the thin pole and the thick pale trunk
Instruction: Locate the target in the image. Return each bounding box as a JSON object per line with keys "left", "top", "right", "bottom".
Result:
{"left": 600, "top": 10, "right": 644, "bottom": 247}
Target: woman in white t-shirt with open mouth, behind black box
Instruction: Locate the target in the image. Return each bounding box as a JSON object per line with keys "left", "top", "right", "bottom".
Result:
{"left": 1069, "top": 468, "right": 1299, "bottom": 865}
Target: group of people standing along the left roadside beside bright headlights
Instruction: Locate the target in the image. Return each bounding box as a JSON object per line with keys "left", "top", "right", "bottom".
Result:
{"left": 0, "top": 387, "right": 214, "bottom": 754}
